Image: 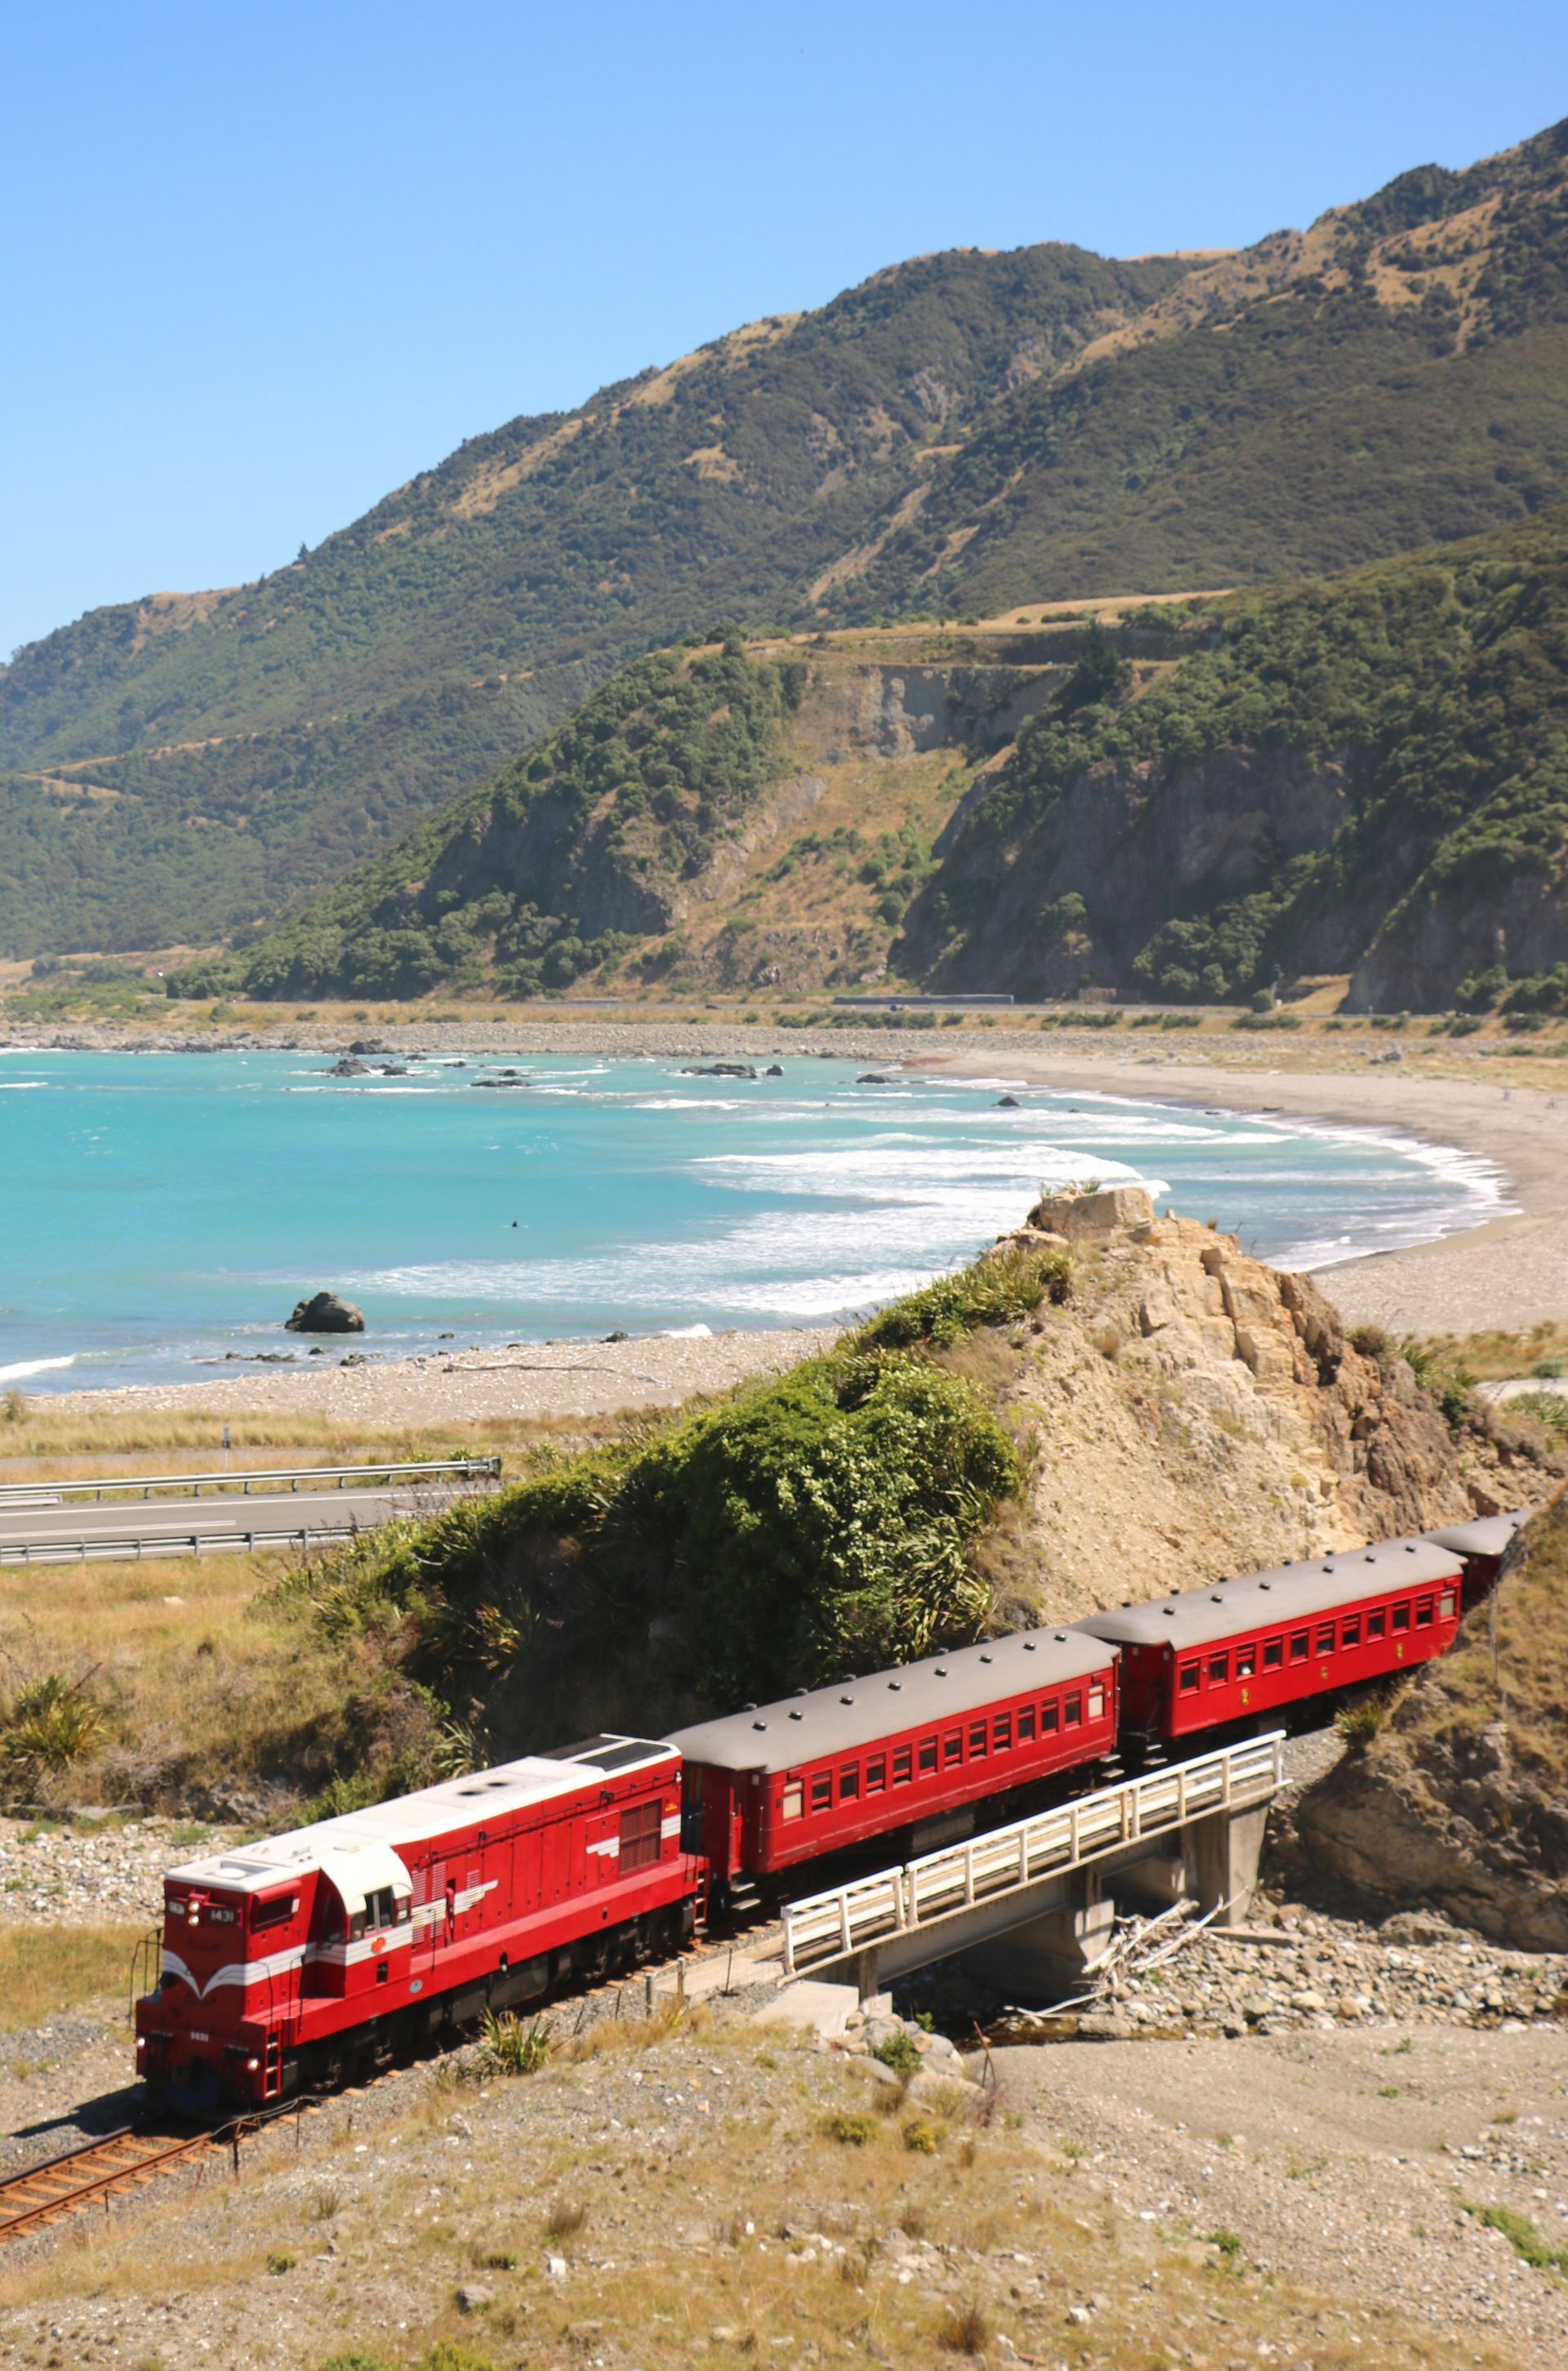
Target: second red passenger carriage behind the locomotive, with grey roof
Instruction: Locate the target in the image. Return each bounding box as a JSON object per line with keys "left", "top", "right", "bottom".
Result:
{"left": 1077, "top": 1539, "right": 1463, "bottom": 1754}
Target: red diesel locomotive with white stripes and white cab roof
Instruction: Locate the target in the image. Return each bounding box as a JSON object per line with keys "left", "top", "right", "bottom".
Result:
{"left": 136, "top": 1738, "right": 697, "bottom": 2113}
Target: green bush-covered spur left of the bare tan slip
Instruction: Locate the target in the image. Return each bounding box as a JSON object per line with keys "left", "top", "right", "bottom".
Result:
{"left": 176, "top": 643, "right": 804, "bottom": 996}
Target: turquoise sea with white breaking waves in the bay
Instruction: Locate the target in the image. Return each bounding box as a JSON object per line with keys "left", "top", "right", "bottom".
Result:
{"left": 0, "top": 1050, "right": 1499, "bottom": 1392}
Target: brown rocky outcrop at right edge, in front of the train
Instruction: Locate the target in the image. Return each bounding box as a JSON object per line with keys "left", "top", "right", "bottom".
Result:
{"left": 1298, "top": 1499, "right": 1568, "bottom": 1951}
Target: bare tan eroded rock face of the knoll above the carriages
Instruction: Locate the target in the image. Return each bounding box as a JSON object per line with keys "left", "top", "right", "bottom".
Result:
{"left": 972, "top": 1188, "right": 1530, "bottom": 1620}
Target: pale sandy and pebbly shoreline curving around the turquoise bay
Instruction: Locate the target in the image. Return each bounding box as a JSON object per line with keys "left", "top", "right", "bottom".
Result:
{"left": 0, "top": 1019, "right": 1568, "bottom": 1428}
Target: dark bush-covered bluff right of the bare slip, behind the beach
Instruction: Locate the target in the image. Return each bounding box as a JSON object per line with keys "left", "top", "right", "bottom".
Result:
{"left": 897, "top": 512, "right": 1568, "bottom": 1010}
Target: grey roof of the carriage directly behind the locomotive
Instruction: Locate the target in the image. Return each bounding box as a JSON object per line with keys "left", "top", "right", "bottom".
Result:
{"left": 669, "top": 1631, "right": 1115, "bottom": 1772}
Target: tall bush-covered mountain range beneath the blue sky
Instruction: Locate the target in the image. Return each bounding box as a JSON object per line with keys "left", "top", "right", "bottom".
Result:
{"left": 0, "top": 106, "right": 1568, "bottom": 953}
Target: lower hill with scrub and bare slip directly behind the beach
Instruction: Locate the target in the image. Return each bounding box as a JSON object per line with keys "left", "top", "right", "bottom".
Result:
{"left": 178, "top": 510, "right": 1568, "bottom": 1010}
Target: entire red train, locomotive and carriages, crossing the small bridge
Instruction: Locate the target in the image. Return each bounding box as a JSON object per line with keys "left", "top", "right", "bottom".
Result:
{"left": 136, "top": 1508, "right": 1530, "bottom": 2117}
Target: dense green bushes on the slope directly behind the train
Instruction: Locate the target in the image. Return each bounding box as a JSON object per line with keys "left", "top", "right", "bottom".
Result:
{"left": 274, "top": 1250, "right": 1070, "bottom": 1783}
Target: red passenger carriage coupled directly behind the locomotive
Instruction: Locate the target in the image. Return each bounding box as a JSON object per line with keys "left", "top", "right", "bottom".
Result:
{"left": 671, "top": 1631, "right": 1117, "bottom": 1899}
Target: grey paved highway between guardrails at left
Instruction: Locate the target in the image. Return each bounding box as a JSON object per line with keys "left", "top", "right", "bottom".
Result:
{"left": 0, "top": 1482, "right": 474, "bottom": 1560}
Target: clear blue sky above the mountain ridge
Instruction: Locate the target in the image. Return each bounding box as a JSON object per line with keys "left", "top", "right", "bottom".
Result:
{"left": 0, "top": 0, "right": 1568, "bottom": 654}
